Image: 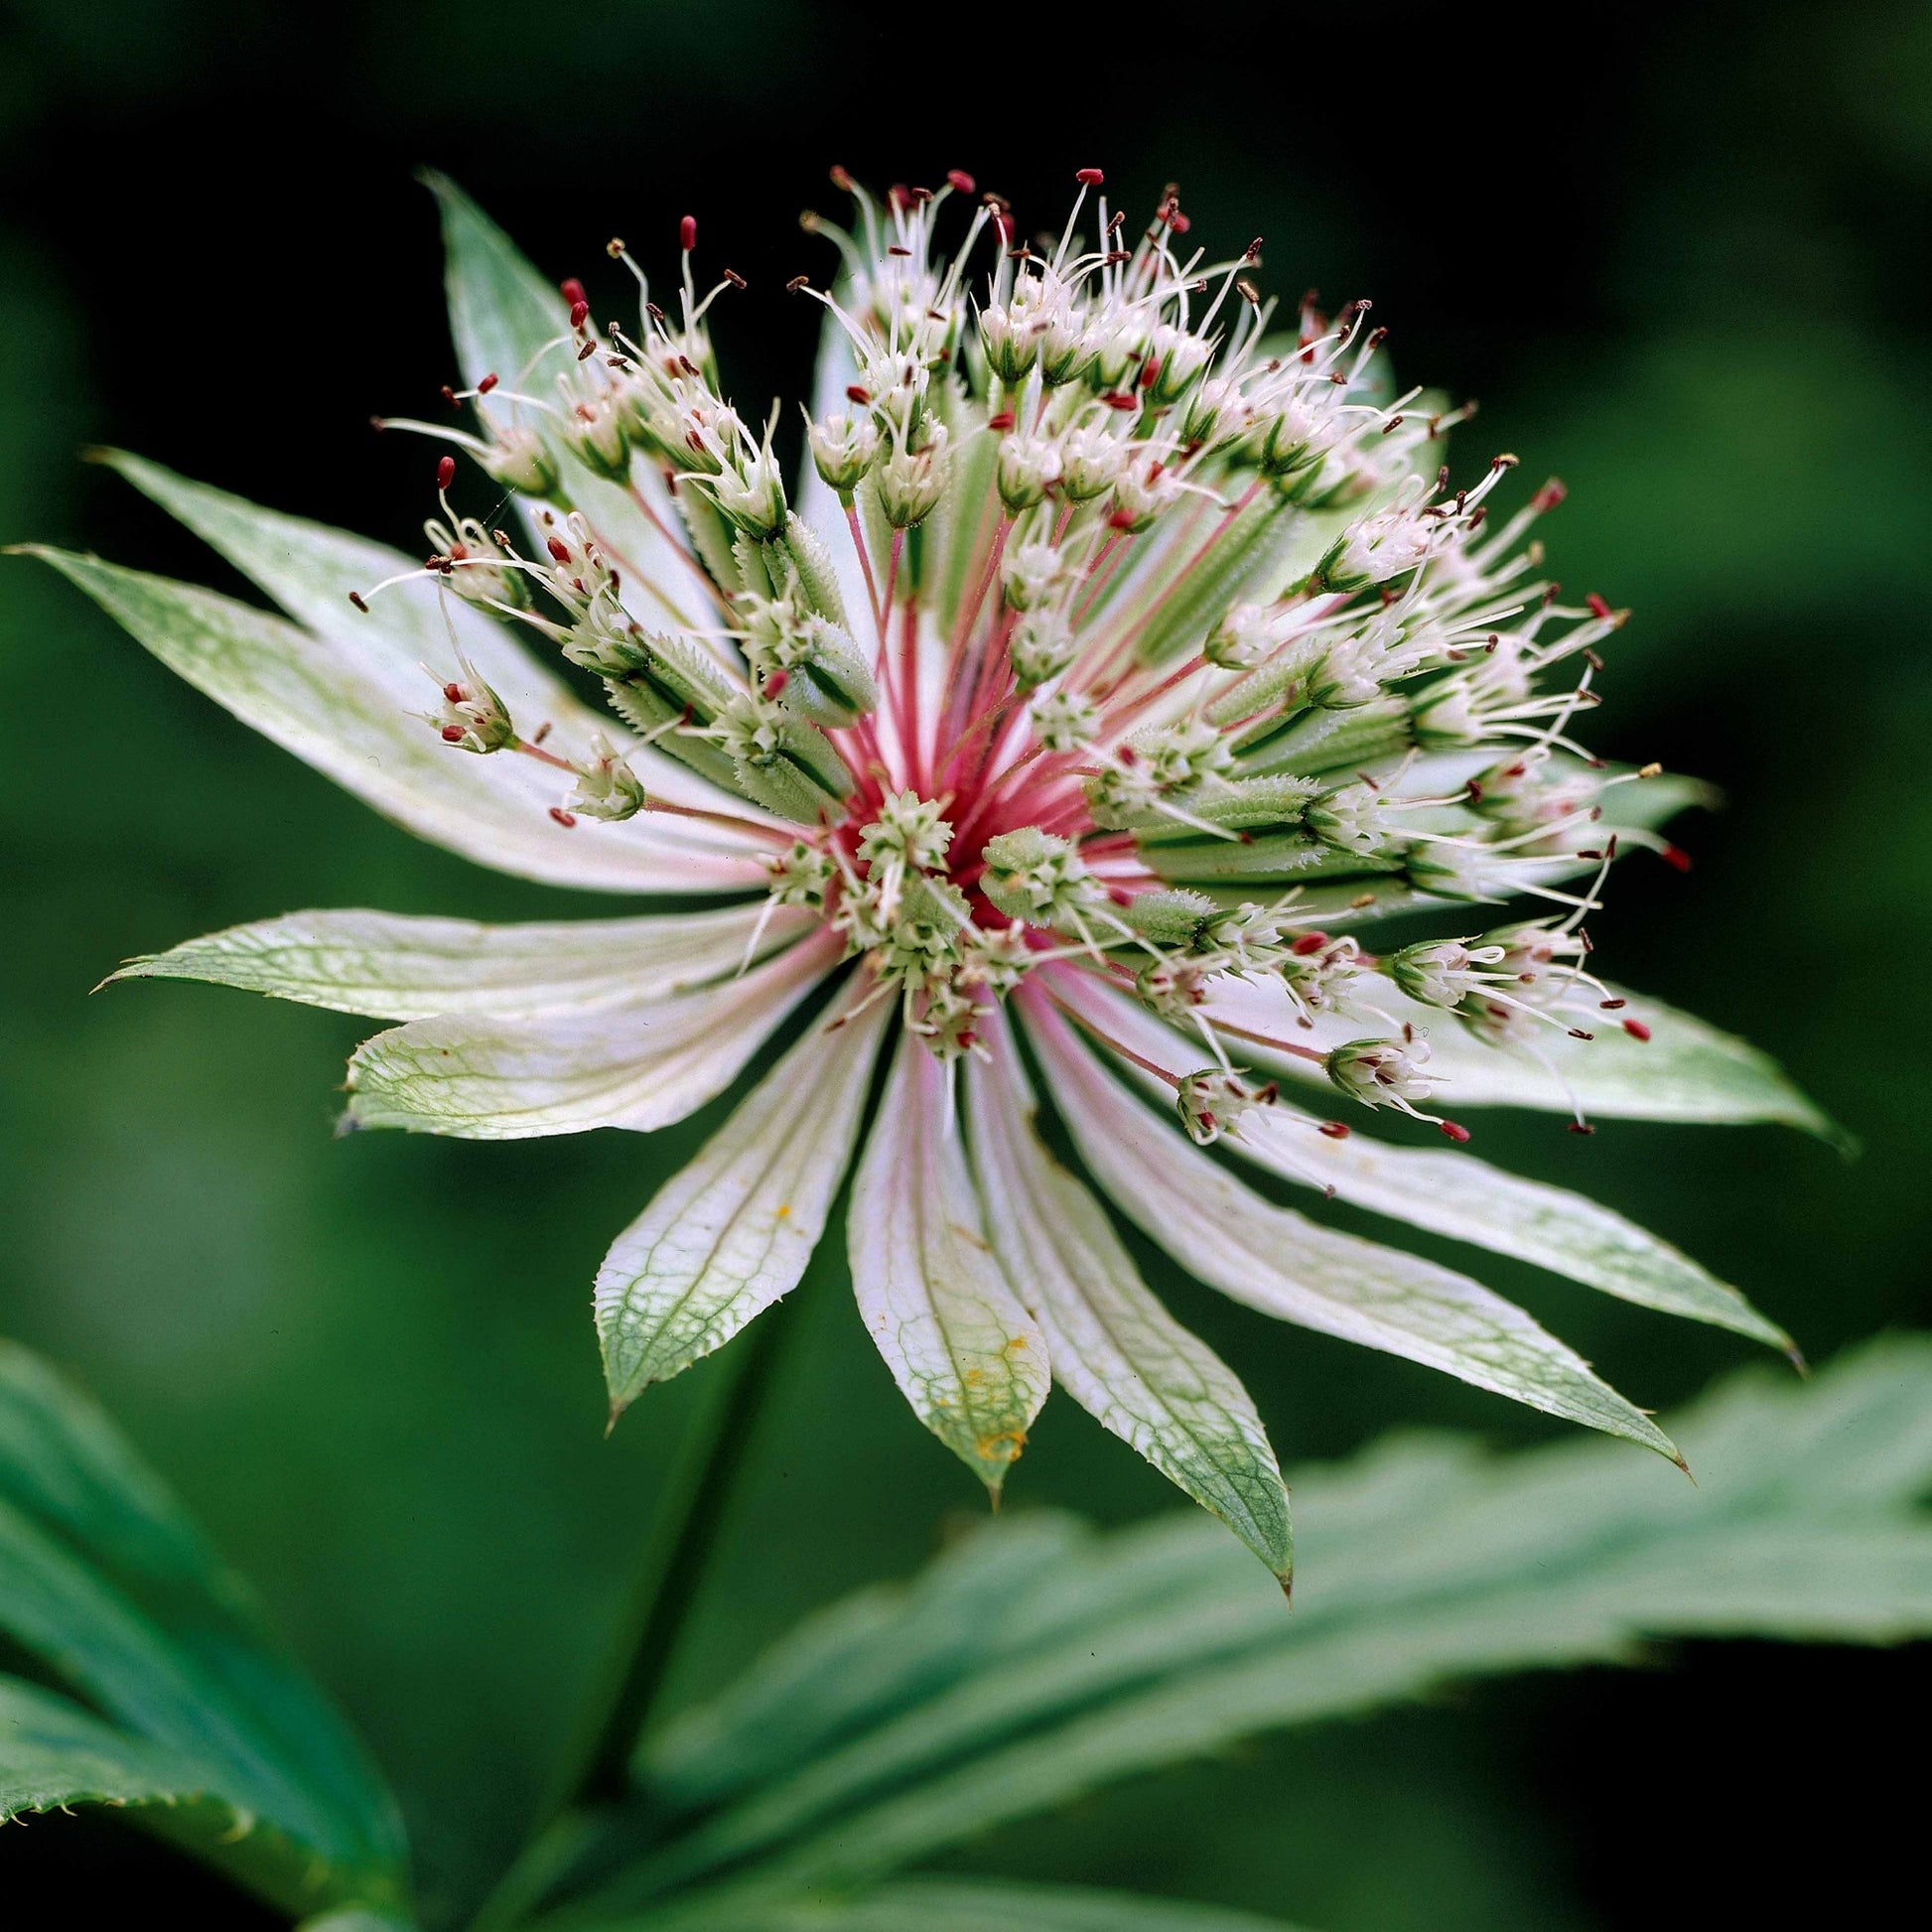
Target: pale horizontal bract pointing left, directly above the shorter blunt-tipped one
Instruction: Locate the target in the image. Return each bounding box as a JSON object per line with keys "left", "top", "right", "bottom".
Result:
{"left": 110, "top": 902, "right": 813, "bottom": 1020}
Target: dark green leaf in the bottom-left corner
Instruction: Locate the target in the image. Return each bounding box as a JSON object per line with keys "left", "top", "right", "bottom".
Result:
{"left": 0, "top": 1344, "right": 404, "bottom": 1911}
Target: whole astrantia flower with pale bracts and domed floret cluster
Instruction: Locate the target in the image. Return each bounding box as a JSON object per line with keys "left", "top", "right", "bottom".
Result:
{"left": 22, "top": 170, "right": 1818, "bottom": 1575}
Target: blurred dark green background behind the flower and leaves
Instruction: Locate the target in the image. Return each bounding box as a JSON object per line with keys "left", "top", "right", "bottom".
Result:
{"left": 0, "top": 0, "right": 1932, "bottom": 1932}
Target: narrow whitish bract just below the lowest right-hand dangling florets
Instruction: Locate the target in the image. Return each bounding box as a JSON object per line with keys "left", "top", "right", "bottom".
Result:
{"left": 1064, "top": 980, "right": 1793, "bottom": 1352}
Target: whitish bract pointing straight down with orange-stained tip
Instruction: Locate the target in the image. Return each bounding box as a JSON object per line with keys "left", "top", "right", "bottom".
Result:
{"left": 846, "top": 1032, "right": 1049, "bottom": 1493}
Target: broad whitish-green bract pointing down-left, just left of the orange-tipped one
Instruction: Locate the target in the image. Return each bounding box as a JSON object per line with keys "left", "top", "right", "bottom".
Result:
{"left": 593, "top": 1001, "right": 887, "bottom": 1414}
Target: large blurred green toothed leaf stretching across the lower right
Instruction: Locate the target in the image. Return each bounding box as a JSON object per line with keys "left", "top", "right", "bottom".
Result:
{"left": 588, "top": 1341, "right": 1932, "bottom": 1918}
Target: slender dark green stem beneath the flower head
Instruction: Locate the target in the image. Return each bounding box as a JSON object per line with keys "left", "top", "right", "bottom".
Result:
{"left": 472, "top": 1310, "right": 784, "bottom": 1932}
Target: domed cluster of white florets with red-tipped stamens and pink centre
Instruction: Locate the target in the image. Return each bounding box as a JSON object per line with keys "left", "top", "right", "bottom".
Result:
{"left": 364, "top": 170, "right": 1658, "bottom": 1140}
